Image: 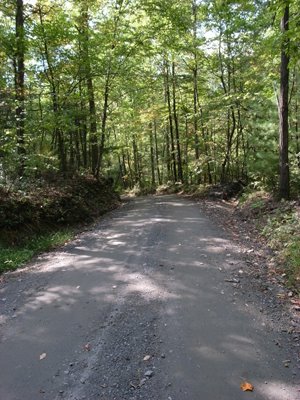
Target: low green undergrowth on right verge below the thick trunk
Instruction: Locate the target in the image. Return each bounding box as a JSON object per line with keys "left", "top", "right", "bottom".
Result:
{"left": 239, "top": 191, "right": 300, "bottom": 293}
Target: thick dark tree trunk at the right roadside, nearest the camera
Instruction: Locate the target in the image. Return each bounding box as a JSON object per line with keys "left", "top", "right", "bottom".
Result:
{"left": 278, "top": 0, "right": 290, "bottom": 199}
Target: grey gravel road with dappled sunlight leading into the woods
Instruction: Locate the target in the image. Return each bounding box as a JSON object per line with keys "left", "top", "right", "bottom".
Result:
{"left": 0, "top": 196, "right": 300, "bottom": 400}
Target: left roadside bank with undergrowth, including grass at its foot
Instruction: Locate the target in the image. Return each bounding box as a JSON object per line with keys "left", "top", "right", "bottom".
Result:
{"left": 0, "top": 176, "right": 120, "bottom": 273}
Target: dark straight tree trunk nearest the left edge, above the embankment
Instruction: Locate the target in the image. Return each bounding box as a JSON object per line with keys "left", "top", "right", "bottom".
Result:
{"left": 15, "top": 0, "right": 25, "bottom": 176}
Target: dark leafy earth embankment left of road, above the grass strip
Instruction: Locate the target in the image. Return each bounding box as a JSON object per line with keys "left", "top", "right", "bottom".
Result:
{"left": 0, "top": 177, "right": 120, "bottom": 244}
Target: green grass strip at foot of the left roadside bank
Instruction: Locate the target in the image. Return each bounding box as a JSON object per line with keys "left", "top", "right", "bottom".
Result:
{"left": 0, "top": 229, "right": 74, "bottom": 273}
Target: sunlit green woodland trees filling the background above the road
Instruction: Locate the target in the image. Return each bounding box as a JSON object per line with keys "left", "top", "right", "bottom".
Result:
{"left": 0, "top": 0, "right": 300, "bottom": 198}
